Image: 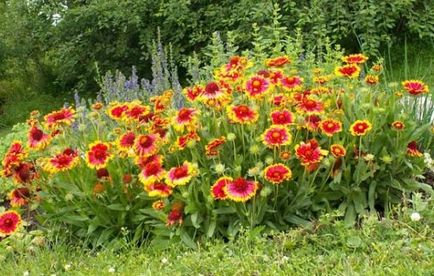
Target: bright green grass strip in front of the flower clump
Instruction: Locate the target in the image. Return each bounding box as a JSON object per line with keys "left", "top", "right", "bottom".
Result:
{"left": 0, "top": 206, "right": 434, "bottom": 275}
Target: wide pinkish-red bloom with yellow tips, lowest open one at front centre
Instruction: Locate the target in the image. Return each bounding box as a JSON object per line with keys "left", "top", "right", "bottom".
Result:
{"left": 224, "top": 177, "right": 259, "bottom": 202}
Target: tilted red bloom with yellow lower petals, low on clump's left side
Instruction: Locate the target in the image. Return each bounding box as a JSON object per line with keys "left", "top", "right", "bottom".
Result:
{"left": 42, "top": 148, "right": 80, "bottom": 174}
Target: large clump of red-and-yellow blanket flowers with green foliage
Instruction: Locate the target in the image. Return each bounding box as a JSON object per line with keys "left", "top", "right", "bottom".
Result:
{"left": 3, "top": 37, "right": 432, "bottom": 247}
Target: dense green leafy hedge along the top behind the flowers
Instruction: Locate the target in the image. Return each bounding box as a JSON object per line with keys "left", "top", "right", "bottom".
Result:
{"left": 0, "top": 0, "right": 434, "bottom": 95}
